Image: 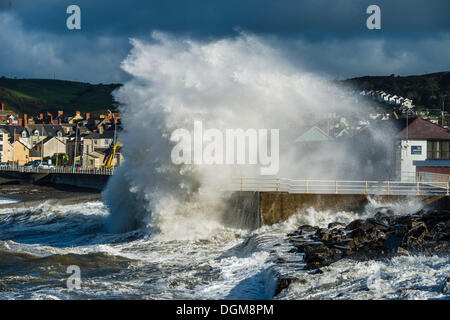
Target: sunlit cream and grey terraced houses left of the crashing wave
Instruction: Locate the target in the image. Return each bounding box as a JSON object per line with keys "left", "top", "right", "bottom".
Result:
{"left": 0, "top": 104, "right": 123, "bottom": 168}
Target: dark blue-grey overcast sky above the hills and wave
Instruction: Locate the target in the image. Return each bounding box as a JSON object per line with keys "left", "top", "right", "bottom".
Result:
{"left": 0, "top": 0, "right": 450, "bottom": 83}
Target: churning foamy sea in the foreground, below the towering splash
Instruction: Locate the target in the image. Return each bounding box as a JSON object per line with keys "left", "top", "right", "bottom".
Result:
{"left": 0, "top": 202, "right": 450, "bottom": 299}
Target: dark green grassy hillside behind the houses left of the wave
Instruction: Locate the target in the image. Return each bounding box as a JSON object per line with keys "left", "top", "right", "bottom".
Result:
{"left": 0, "top": 77, "right": 121, "bottom": 114}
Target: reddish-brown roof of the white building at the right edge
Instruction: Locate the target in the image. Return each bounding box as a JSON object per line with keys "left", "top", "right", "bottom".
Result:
{"left": 397, "top": 118, "right": 450, "bottom": 140}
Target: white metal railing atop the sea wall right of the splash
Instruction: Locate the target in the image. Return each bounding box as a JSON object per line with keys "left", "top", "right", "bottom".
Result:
{"left": 229, "top": 177, "right": 449, "bottom": 195}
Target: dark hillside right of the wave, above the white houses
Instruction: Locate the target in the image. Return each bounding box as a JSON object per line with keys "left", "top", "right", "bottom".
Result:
{"left": 343, "top": 71, "right": 450, "bottom": 111}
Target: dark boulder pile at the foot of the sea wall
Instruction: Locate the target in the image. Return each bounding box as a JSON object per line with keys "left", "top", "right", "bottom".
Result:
{"left": 288, "top": 210, "right": 450, "bottom": 272}
